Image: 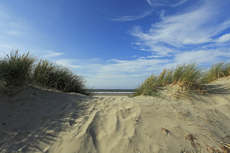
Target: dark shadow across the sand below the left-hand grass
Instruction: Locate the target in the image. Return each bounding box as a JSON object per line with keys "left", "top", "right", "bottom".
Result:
{"left": 0, "top": 87, "right": 93, "bottom": 152}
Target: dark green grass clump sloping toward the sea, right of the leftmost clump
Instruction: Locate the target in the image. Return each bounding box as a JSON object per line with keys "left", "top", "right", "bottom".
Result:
{"left": 33, "top": 60, "right": 90, "bottom": 95}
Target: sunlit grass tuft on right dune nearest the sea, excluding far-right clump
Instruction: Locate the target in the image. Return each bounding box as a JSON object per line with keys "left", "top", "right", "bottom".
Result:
{"left": 134, "top": 63, "right": 210, "bottom": 96}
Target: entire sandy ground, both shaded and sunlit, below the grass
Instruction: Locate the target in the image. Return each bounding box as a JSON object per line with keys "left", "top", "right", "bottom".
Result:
{"left": 0, "top": 78, "right": 230, "bottom": 153}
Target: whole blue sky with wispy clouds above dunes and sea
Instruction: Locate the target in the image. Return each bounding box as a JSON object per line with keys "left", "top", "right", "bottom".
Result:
{"left": 0, "top": 0, "right": 230, "bottom": 89}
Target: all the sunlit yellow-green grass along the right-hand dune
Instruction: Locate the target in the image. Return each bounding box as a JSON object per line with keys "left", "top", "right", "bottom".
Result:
{"left": 133, "top": 62, "right": 230, "bottom": 96}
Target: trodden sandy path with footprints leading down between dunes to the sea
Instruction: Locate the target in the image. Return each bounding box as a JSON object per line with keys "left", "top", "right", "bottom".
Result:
{"left": 50, "top": 97, "right": 140, "bottom": 152}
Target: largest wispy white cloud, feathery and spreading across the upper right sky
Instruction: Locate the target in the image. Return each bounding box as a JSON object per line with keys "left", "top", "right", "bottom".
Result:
{"left": 131, "top": 0, "right": 230, "bottom": 55}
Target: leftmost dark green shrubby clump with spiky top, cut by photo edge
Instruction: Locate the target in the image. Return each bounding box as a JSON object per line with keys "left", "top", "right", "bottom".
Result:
{"left": 0, "top": 51, "right": 35, "bottom": 86}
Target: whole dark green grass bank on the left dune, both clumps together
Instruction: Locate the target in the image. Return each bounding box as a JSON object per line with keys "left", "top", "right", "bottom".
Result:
{"left": 0, "top": 51, "right": 90, "bottom": 95}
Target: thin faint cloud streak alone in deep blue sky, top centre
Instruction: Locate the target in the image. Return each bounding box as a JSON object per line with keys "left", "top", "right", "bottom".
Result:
{"left": 111, "top": 11, "right": 153, "bottom": 21}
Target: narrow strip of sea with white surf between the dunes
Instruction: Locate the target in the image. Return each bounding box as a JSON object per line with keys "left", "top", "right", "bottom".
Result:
{"left": 92, "top": 89, "right": 135, "bottom": 95}
